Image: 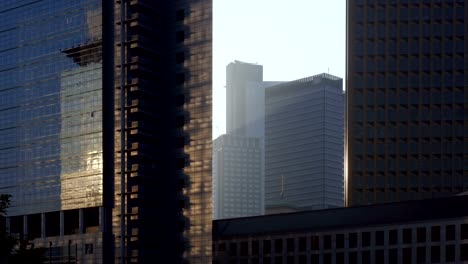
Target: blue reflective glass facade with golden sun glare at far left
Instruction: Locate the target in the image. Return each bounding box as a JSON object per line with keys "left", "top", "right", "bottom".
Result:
{"left": 0, "top": 0, "right": 102, "bottom": 216}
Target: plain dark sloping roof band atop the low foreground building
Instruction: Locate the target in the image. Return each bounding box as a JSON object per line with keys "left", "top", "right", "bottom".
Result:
{"left": 213, "top": 195, "right": 468, "bottom": 239}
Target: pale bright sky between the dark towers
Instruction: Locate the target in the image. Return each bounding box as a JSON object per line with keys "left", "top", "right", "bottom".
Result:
{"left": 213, "top": 0, "right": 346, "bottom": 139}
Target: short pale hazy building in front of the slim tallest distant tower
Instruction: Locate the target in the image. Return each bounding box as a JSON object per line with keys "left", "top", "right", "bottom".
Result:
{"left": 213, "top": 135, "right": 264, "bottom": 219}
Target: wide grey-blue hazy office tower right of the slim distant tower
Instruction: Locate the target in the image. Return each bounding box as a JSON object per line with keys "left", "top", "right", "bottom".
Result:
{"left": 265, "top": 73, "right": 344, "bottom": 213}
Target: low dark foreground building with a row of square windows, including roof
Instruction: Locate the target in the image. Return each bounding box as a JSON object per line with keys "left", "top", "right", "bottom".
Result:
{"left": 213, "top": 196, "right": 468, "bottom": 264}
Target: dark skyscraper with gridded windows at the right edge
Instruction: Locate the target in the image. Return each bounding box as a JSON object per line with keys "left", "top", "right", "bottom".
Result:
{"left": 346, "top": 0, "right": 468, "bottom": 205}
